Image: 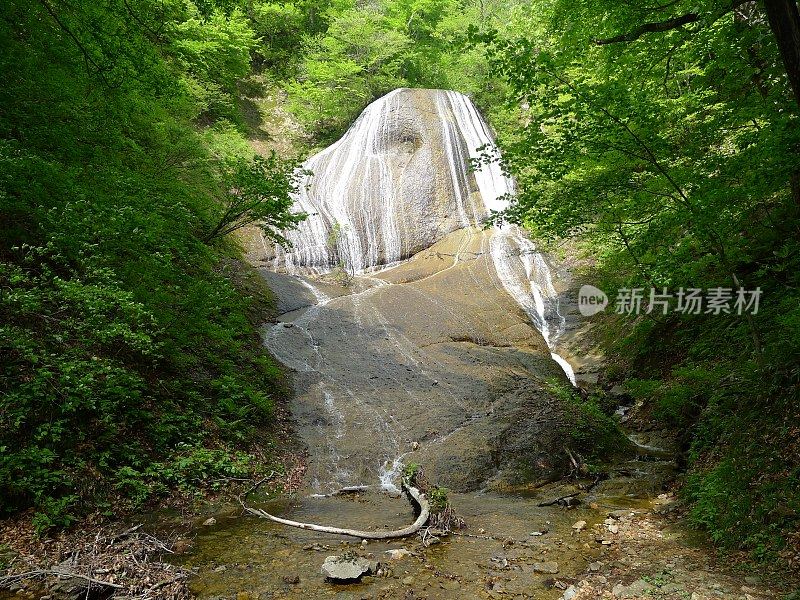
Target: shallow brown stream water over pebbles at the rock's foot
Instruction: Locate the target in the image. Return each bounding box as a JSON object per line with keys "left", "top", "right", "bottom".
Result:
{"left": 183, "top": 462, "right": 676, "bottom": 599}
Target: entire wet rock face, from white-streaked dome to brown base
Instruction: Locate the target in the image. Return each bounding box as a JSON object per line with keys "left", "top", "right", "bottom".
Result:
{"left": 264, "top": 89, "right": 571, "bottom": 491}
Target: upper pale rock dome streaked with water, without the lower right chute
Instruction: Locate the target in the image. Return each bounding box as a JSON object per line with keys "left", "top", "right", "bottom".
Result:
{"left": 264, "top": 88, "right": 516, "bottom": 272}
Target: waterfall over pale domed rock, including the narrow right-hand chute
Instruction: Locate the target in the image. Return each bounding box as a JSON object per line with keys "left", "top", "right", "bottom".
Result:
{"left": 274, "top": 89, "right": 575, "bottom": 384}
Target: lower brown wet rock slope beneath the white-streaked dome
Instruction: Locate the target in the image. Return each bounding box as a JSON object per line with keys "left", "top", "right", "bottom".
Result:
{"left": 265, "top": 229, "right": 571, "bottom": 492}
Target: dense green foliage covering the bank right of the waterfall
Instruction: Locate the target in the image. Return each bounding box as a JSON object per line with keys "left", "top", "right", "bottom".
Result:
{"left": 470, "top": 0, "right": 800, "bottom": 558}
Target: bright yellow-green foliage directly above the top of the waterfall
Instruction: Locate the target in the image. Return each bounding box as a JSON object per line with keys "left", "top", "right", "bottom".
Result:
{"left": 278, "top": 0, "right": 518, "bottom": 144}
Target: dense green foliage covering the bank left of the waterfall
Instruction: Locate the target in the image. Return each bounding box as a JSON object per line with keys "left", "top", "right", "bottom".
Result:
{"left": 0, "top": 0, "right": 300, "bottom": 530}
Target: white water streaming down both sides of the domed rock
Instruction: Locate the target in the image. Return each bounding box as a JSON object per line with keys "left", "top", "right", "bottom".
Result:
{"left": 276, "top": 90, "right": 575, "bottom": 384}
